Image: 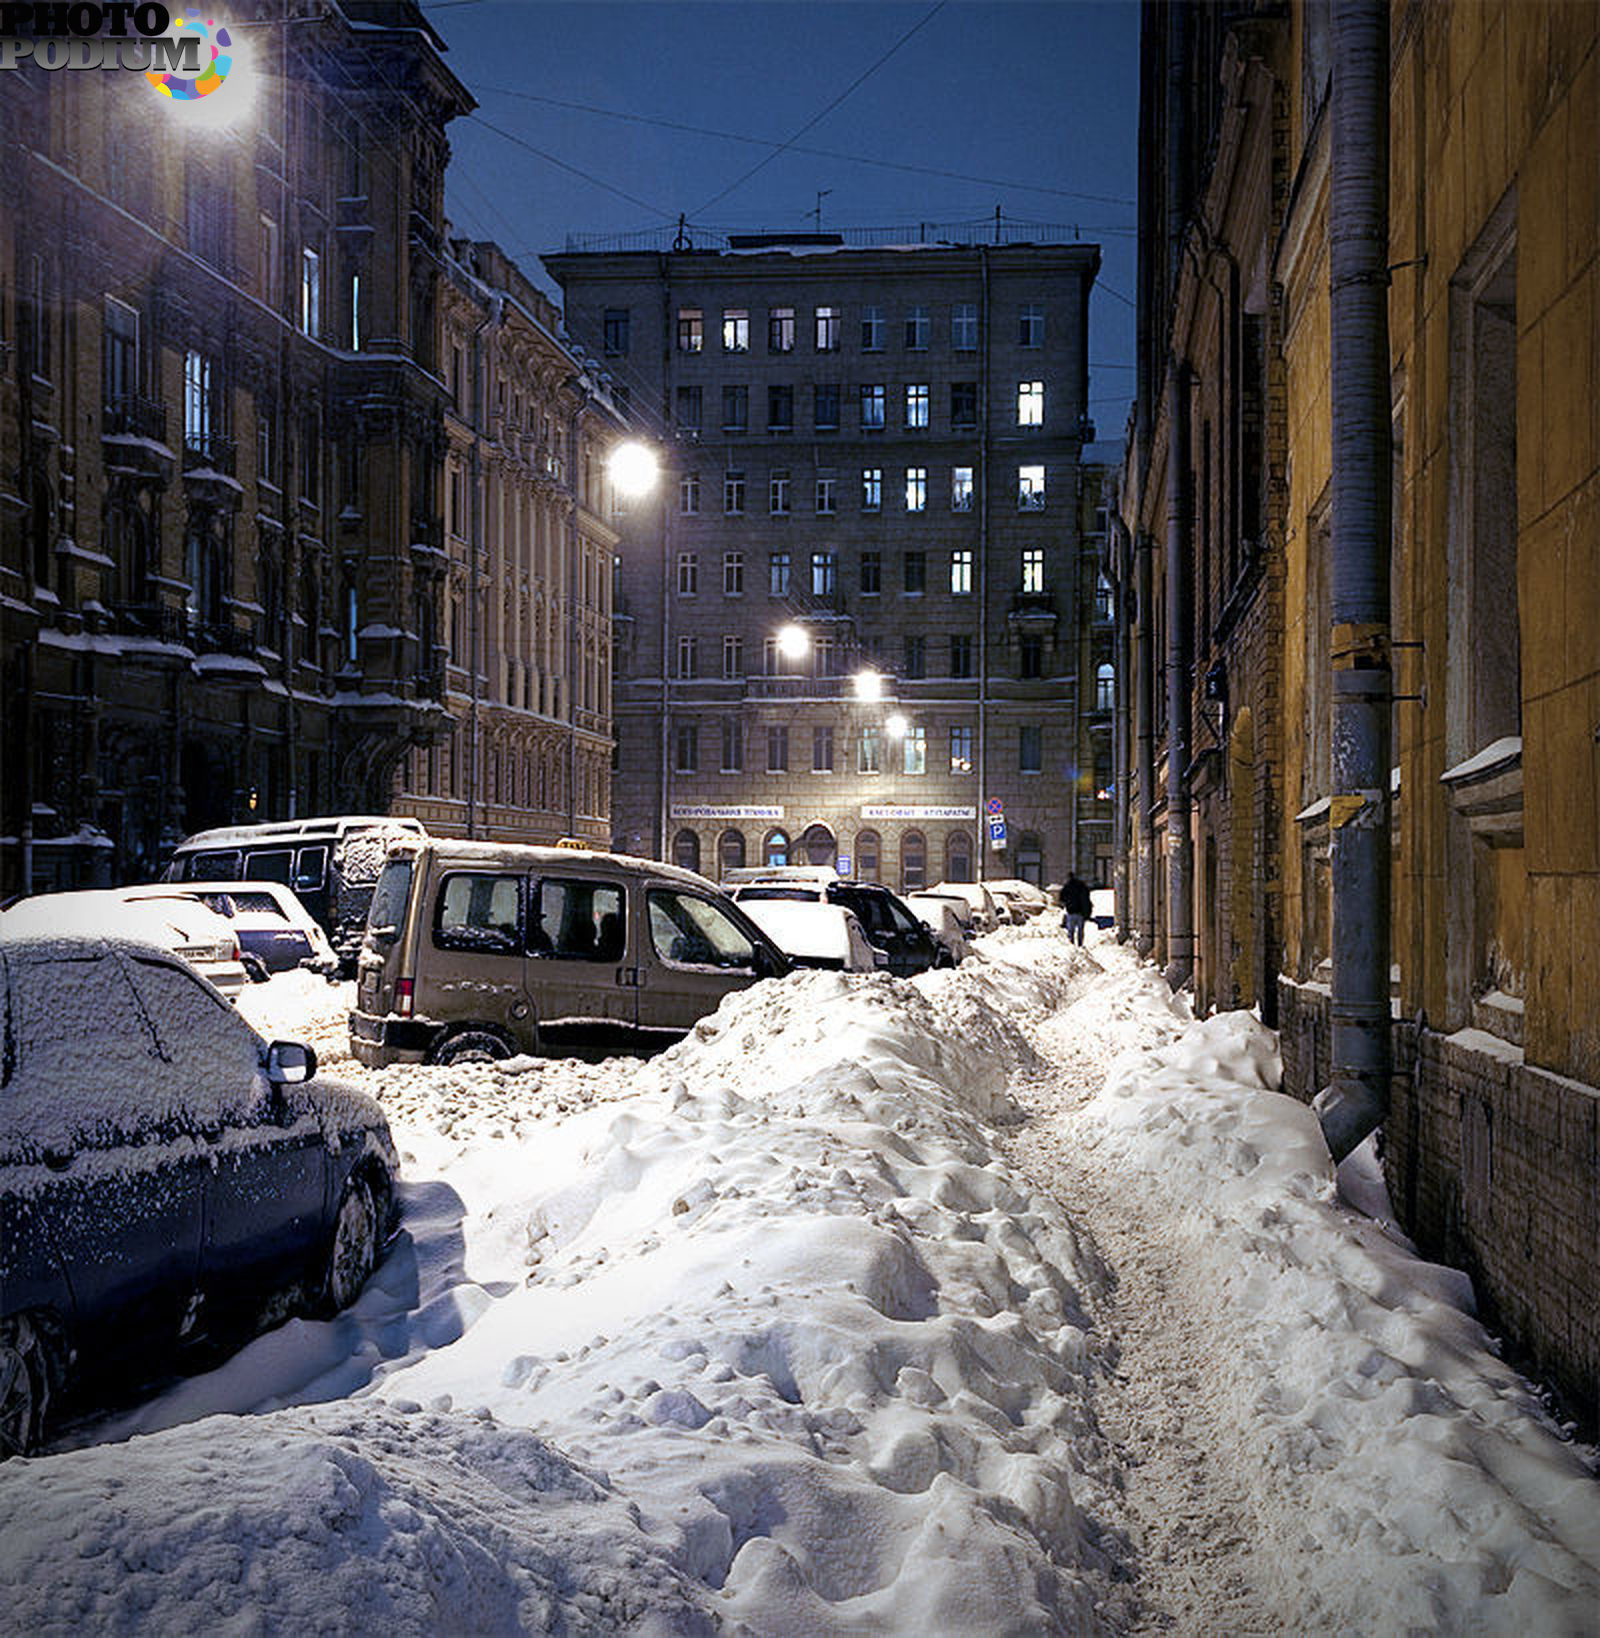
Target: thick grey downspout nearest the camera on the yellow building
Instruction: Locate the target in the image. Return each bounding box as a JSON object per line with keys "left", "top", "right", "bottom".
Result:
{"left": 1313, "top": 0, "right": 1394, "bottom": 1161}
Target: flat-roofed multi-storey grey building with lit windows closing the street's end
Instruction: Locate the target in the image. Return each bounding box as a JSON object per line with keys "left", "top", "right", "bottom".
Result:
{"left": 545, "top": 234, "right": 1110, "bottom": 888}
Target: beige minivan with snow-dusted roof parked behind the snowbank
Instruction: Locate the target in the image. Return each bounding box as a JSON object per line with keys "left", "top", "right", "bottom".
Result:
{"left": 350, "top": 839, "right": 789, "bottom": 1068}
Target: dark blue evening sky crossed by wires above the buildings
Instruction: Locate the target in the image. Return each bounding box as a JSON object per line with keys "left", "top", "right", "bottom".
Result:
{"left": 424, "top": 0, "right": 1138, "bottom": 437}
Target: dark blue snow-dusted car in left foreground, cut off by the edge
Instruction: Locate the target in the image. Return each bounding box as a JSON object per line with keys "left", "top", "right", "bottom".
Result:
{"left": 0, "top": 930, "right": 398, "bottom": 1455}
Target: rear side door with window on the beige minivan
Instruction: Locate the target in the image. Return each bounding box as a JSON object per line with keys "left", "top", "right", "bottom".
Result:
{"left": 527, "top": 873, "right": 639, "bottom": 1055}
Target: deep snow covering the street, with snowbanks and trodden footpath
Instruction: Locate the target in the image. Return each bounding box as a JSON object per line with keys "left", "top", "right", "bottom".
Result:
{"left": 0, "top": 917, "right": 1600, "bottom": 1635}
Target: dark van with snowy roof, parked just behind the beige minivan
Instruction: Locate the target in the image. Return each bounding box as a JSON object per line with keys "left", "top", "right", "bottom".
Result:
{"left": 162, "top": 814, "right": 427, "bottom": 978}
